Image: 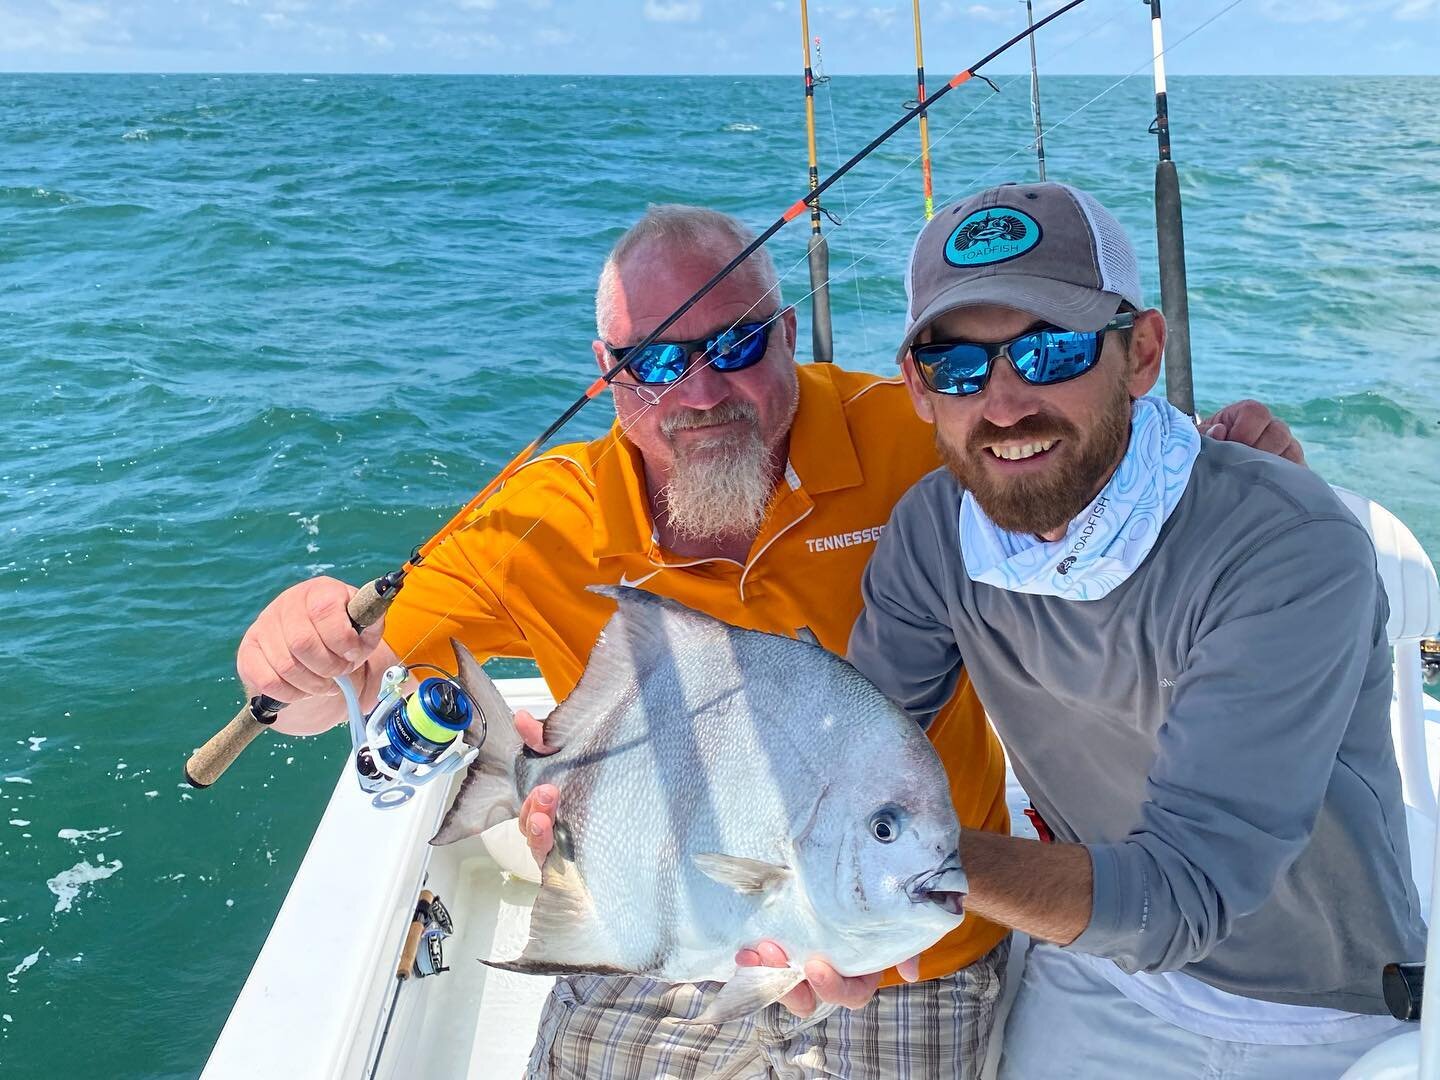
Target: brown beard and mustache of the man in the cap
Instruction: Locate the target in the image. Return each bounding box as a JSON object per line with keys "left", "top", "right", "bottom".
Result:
{"left": 935, "top": 380, "right": 1130, "bottom": 534}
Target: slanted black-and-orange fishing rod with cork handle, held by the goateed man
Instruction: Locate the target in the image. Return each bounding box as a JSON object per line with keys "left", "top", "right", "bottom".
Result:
{"left": 184, "top": 0, "right": 1084, "bottom": 788}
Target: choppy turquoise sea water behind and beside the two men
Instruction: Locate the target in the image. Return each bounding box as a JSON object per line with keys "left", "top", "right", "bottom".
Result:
{"left": 0, "top": 76, "right": 1440, "bottom": 1077}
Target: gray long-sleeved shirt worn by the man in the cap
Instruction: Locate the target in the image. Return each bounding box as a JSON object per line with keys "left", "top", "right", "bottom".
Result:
{"left": 850, "top": 439, "right": 1424, "bottom": 1014}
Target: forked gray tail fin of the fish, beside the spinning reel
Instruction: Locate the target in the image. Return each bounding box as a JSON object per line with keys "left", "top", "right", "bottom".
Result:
{"left": 431, "top": 638, "right": 524, "bottom": 845}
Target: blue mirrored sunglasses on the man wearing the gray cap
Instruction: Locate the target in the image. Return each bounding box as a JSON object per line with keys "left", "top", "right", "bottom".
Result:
{"left": 910, "top": 311, "right": 1135, "bottom": 397}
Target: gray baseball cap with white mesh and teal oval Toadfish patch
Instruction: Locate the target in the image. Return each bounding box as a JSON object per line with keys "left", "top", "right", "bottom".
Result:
{"left": 896, "top": 183, "right": 1145, "bottom": 360}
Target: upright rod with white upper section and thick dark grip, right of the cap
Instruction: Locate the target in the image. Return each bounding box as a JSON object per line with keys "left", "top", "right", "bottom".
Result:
{"left": 1142, "top": 0, "right": 1195, "bottom": 416}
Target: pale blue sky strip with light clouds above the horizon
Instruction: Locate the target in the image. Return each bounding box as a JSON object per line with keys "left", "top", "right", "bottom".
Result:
{"left": 0, "top": 0, "right": 1440, "bottom": 78}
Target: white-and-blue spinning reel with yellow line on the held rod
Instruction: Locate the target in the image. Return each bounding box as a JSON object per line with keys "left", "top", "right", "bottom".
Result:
{"left": 336, "top": 664, "right": 485, "bottom": 809}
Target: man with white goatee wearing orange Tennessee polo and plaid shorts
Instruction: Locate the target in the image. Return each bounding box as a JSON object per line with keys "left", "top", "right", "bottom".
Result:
{"left": 238, "top": 207, "right": 1299, "bottom": 1080}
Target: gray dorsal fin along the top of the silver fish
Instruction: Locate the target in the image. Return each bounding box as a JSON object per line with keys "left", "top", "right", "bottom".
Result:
{"left": 544, "top": 585, "right": 730, "bottom": 747}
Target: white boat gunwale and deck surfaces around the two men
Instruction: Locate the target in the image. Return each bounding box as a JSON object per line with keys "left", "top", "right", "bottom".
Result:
{"left": 204, "top": 680, "right": 1440, "bottom": 1080}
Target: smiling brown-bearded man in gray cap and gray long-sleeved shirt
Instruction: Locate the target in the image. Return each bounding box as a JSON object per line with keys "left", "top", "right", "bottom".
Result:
{"left": 850, "top": 184, "right": 1424, "bottom": 1079}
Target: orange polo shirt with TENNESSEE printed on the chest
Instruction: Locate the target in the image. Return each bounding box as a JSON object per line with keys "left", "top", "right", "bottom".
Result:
{"left": 384, "top": 364, "right": 1009, "bottom": 982}
